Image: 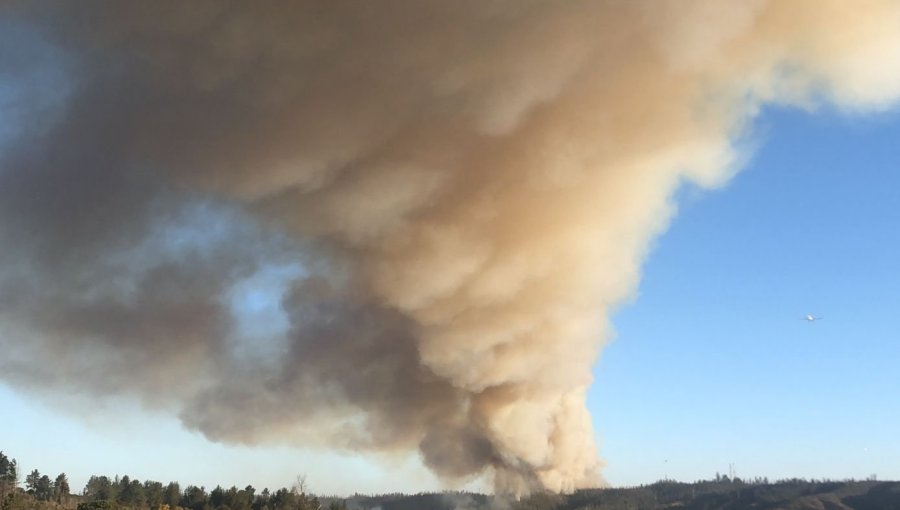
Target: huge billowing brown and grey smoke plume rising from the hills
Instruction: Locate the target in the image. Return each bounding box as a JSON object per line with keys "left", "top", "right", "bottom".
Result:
{"left": 0, "top": 0, "right": 900, "bottom": 492}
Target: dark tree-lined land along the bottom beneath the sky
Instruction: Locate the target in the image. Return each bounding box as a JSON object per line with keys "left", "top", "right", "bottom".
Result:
{"left": 0, "top": 452, "right": 900, "bottom": 510}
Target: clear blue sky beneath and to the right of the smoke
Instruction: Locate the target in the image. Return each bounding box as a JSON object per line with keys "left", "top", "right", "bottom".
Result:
{"left": 0, "top": 102, "right": 900, "bottom": 493}
